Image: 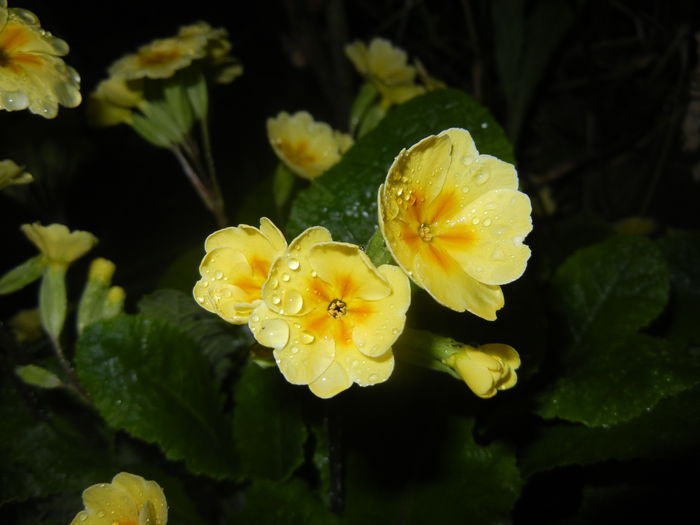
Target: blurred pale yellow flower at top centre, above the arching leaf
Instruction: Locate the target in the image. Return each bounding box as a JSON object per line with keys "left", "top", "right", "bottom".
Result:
{"left": 345, "top": 38, "right": 425, "bottom": 106}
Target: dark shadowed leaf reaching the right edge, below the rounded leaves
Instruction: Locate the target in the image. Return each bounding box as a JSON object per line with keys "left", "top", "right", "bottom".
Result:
{"left": 519, "top": 382, "right": 700, "bottom": 476}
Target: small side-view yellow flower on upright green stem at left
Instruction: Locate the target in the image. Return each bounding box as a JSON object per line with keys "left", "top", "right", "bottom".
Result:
{"left": 21, "top": 222, "right": 97, "bottom": 266}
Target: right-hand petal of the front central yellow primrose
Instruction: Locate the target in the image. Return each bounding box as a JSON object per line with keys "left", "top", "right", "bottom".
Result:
{"left": 351, "top": 264, "right": 411, "bottom": 358}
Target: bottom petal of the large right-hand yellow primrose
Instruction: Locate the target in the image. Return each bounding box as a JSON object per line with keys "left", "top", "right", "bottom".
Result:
{"left": 413, "top": 250, "right": 504, "bottom": 321}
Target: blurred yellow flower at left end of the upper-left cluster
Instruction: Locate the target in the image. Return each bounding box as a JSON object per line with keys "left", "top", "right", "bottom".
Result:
{"left": 87, "top": 76, "right": 144, "bottom": 126}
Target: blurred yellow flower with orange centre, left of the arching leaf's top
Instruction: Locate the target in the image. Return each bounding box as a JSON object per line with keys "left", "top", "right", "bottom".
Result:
{"left": 267, "top": 111, "right": 353, "bottom": 180}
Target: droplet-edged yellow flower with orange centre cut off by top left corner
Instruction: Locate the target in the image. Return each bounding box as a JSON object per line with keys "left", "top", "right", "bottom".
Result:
{"left": 0, "top": 0, "right": 81, "bottom": 118}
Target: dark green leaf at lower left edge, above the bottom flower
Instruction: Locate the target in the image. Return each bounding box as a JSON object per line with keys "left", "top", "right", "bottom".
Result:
{"left": 0, "top": 376, "right": 115, "bottom": 504}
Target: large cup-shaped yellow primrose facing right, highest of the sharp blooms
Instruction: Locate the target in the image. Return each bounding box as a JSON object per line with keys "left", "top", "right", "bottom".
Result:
{"left": 379, "top": 128, "right": 532, "bottom": 320}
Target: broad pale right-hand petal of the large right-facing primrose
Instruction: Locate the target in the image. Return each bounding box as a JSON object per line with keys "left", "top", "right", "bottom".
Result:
{"left": 435, "top": 190, "right": 532, "bottom": 284}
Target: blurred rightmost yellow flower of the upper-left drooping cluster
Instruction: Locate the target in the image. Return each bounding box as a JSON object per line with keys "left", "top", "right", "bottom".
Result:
{"left": 177, "top": 21, "right": 243, "bottom": 84}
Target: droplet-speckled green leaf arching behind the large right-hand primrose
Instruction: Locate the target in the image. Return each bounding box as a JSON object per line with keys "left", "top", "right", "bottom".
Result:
{"left": 287, "top": 89, "right": 513, "bottom": 245}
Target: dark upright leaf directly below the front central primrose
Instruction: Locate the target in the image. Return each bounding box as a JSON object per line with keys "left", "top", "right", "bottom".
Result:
{"left": 233, "top": 363, "right": 306, "bottom": 480}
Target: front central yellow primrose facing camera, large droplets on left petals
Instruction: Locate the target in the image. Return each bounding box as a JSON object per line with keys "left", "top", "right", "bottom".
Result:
{"left": 249, "top": 227, "right": 410, "bottom": 398}
